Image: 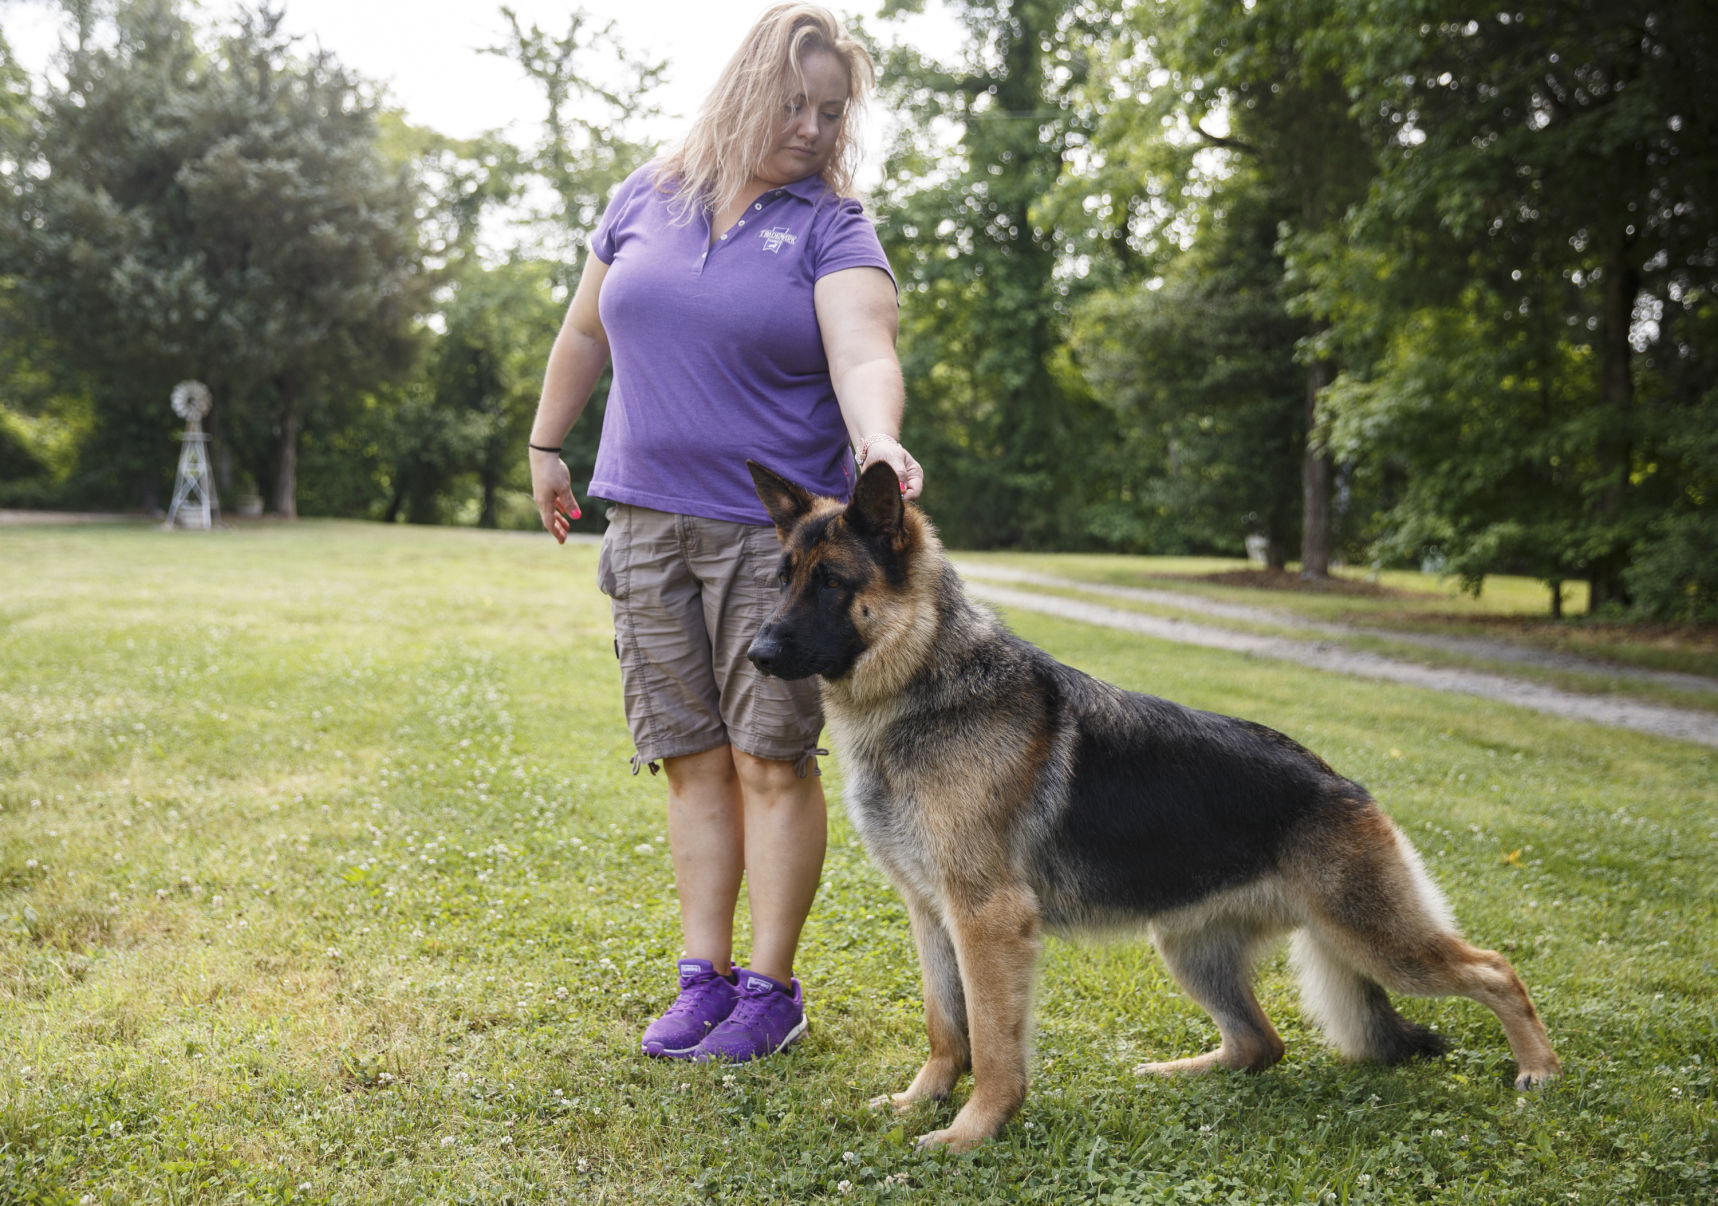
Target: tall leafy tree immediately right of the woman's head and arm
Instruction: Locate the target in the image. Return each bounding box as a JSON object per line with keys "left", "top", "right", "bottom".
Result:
{"left": 878, "top": 0, "right": 1117, "bottom": 546}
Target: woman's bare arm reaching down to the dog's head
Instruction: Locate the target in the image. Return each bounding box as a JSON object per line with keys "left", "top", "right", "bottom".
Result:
{"left": 813, "top": 268, "right": 924, "bottom": 498}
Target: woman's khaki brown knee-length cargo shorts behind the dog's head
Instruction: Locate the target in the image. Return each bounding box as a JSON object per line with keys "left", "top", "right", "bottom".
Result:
{"left": 596, "top": 503, "right": 823, "bottom": 777}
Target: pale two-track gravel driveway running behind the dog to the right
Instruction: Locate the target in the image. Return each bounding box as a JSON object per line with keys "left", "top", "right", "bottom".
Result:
{"left": 957, "top": 562, "right": 1718, "bottom": 749}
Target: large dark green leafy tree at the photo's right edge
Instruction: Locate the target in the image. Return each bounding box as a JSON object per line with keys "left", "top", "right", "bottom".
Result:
{"left": 1307, "top": 0, "right": 1718, "bottom": 610}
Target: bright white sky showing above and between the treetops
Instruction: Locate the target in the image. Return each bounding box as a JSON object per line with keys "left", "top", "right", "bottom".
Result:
{"left": 0, "top": 0, "right": 959, "bottom": 151}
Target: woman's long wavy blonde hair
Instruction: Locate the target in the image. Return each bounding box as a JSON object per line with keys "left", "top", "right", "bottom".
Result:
{"left": 656, "top": 3, "right": 876, "bottom": 222}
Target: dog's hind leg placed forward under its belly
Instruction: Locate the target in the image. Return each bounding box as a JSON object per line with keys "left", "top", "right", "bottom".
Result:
{"left": 1134, "top": 924, "right": 1283, "bottom": 1075}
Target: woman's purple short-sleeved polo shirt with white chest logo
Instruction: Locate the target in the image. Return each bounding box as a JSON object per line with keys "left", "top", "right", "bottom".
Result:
{"left": 589, "top": 165, "right": 893, "bottom": 524}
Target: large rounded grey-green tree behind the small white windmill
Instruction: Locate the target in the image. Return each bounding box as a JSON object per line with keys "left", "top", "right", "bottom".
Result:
{"left": 0, "top": 0, "right": 423, "bottom": 515}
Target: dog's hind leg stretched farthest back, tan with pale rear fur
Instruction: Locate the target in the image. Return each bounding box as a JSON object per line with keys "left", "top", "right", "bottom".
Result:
{"left": 1299, "top": 811, "right": 1562, "bottom": 1089}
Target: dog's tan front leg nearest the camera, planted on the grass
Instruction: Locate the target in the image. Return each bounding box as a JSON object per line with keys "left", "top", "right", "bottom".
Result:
{"left": 919, "top": 885, "right": 1039, "bottom": 1151}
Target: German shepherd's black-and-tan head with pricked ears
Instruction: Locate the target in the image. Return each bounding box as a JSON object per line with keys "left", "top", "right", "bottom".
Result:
{"left": 746, "top": 460, "right": 923, "bottom": 680}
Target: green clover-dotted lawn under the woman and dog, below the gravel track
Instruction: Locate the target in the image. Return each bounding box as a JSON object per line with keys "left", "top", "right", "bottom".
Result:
{"left": 0, "top": 522, "right": 1718, "bottom": 1206}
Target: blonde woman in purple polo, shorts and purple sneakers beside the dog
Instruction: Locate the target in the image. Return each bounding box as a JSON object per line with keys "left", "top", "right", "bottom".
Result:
{"left": 529, "top": 5, "right": 923, "bottom": 1060}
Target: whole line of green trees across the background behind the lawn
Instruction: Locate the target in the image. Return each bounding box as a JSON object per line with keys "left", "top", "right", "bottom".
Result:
{"left": 0, "top": 0, "right": 1718, "bottom": 620}
